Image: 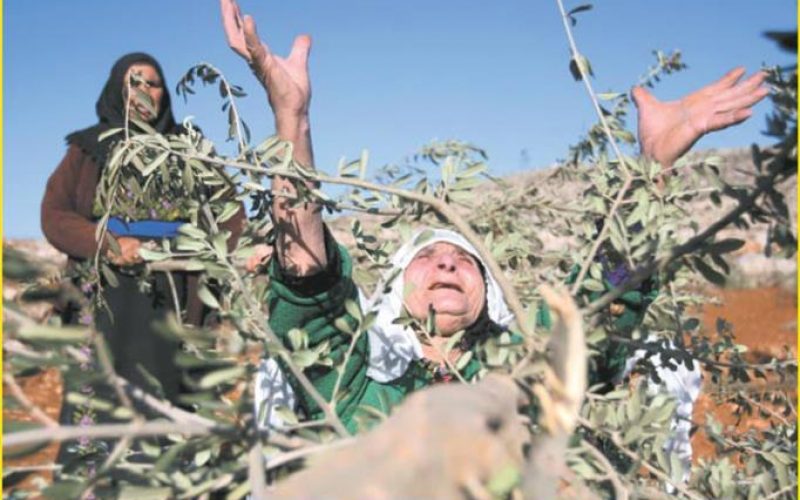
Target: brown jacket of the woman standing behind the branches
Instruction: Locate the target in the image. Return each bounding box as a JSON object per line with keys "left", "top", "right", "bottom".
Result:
{"left": 41, "top": 145, "right": 245, "bottom": 325}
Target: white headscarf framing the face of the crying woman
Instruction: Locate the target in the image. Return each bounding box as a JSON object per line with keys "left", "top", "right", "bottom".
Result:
{"left": 362, "top": 229, "right": 514, "bottom": 382}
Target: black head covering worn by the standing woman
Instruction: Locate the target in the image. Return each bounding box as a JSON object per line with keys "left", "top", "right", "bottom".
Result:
{"left": 66, "top": 52, "right": 181, "bottom": 168}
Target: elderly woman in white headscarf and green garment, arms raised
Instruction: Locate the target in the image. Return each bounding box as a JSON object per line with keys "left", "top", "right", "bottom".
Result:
{"left": 221, "top": 0, "right": 766, "bottom": 438}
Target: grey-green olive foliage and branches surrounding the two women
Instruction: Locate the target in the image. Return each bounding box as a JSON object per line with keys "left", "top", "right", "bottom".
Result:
{"left": 4, "top": 6, "right": 797, "bottom": 499}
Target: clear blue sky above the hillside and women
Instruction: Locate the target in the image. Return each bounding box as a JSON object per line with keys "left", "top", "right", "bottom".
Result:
{"left": 3, "top": 0, "right": 797, "bottom": 238}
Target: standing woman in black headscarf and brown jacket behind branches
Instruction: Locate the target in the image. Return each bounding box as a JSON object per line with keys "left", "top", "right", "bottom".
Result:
{"left": 41, "top": 53, "right": 244, "bottom": 450}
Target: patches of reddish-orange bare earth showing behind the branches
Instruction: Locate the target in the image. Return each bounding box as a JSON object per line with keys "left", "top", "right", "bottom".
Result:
{"left": 3, "top": 288, "right": 797, "bottom": 487}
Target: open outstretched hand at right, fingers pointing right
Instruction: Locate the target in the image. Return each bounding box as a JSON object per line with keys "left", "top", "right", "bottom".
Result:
{"left": 633, "top": 68, "right": 769, "bottom": 166}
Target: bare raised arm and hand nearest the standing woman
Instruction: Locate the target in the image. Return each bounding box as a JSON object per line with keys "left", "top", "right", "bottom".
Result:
{"left": 220, "top": 0, "right": 327, "bottom": 276}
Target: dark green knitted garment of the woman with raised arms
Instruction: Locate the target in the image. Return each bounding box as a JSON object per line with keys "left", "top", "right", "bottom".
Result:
{"left": 268, "top": 242, "right": 649, "bottom": 432}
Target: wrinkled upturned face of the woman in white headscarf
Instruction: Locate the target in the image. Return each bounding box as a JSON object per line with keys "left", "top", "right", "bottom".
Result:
{"left": 403, "top": 242, "right": 486, "bottom": 336}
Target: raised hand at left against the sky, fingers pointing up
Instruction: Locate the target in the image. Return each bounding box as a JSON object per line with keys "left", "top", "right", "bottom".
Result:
{"left": 220, "top": 0, "right": 311, "bottom": 120}
